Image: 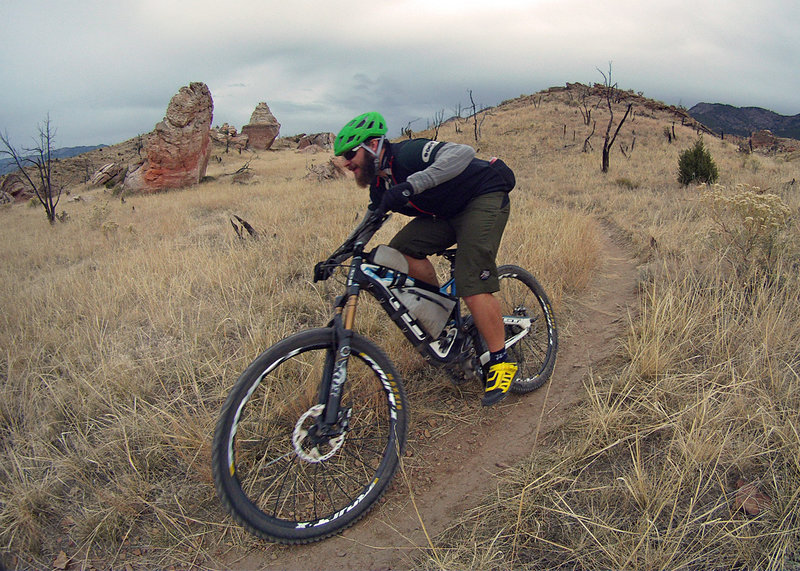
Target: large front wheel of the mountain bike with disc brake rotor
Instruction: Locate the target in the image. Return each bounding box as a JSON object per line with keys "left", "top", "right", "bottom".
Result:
{"left": 212, "top": 328, "right": 407, "bottom": 543}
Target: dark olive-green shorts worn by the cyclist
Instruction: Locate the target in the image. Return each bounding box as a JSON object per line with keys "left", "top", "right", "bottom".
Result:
{"left": 389, "top": 192, "right": 511, "bottom": 297}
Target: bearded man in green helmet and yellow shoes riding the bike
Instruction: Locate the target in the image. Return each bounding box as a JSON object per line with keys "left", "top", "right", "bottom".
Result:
{"left": 334, "top": 111, "right": 517, "bottom": 406}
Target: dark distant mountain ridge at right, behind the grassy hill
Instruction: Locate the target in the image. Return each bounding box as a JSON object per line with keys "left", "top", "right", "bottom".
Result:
{"left": 689, "top": 103, "right": 800, "bottom": 139}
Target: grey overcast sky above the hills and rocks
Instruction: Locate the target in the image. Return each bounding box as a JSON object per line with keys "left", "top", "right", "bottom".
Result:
{"left": 0, "top": 0, "right": 800, "bottom": 147}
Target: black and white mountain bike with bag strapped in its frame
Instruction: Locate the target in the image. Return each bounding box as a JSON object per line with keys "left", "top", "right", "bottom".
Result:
{"left": 212, "top": 212, "right": 558, "bottom": 543}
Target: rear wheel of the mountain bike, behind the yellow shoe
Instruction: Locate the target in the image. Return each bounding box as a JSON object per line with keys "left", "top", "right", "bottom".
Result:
{"left": 494, "top": 265, "right": 558, "bottom": 393}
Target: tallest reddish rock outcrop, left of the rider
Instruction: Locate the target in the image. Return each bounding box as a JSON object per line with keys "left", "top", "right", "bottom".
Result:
{"left": 124, "top": 82, "right": 214, "bottom": 192}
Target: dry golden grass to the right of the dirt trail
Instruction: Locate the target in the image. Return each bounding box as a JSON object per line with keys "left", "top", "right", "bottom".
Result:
{"left": 418, "top": 91, "right": 800, "bottom": 569}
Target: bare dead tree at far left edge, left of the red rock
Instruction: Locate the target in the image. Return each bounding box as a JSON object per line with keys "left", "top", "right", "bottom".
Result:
{"left": 0, "top": 114, "right": 63, "bottom": 224}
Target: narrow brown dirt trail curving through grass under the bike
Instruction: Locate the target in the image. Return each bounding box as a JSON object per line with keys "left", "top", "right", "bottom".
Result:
{"left": 222, "top": 228, "right": 637, "bottom": 571}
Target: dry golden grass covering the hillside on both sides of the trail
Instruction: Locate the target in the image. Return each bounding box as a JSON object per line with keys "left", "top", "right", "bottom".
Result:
{"left": 0, "top": 86, "right": 800, "bottom": 569}
